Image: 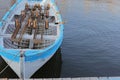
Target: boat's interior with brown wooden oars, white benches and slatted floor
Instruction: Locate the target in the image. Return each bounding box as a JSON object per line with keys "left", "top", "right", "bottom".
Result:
{"left": 2, "top": 3, "right": 58, "bottom": 49}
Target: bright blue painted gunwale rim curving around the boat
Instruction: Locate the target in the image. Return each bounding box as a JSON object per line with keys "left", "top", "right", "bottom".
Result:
{"left": 0, "top": 0, "right": 64, "bottom": 62}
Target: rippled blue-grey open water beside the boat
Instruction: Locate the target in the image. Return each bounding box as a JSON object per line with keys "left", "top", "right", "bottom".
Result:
{"left": 0, "top": 0, "right": 120, "bottom": 77}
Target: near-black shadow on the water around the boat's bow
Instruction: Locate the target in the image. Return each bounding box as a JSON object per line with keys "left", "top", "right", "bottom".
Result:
{"left": 0, "top": 48, "right": 62, "bottom": 78}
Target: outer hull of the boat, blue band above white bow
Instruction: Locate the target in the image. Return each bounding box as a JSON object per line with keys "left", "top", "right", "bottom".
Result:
{"left": 0, "top": 0, "right": 64, "bottom": 78}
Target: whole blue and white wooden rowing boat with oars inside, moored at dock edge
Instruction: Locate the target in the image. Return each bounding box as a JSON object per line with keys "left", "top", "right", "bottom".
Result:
{"left": 0, "top": 0, "right": 64, "bottom": 78}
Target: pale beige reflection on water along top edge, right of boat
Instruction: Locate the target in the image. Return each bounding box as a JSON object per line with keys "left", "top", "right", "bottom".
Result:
{"left": 56, "top": 0, "right": 120, "bottom": 14}
